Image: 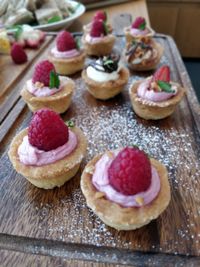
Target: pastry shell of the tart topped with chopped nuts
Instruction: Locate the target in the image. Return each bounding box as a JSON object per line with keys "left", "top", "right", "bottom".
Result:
{"left": 125, "top": 41, "right": 164, "bottom": 71}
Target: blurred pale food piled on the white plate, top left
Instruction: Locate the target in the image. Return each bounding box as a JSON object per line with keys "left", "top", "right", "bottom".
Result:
{"left": 0, "top": 0, "right": 76, "bottom": 26}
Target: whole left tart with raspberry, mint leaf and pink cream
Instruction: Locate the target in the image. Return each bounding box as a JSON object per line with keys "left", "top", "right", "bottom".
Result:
{"left": 21, "top": 60, "right": 75, "bottom": 113}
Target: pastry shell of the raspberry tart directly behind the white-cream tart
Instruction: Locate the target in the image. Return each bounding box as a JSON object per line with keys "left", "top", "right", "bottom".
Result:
{"left": 82, "top": 34, "right": 116, "bottom": 56}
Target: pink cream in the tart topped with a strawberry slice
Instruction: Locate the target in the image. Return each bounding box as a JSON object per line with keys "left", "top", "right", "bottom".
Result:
{"left": 137, "top": 77, "right": 177, "bottom": 102}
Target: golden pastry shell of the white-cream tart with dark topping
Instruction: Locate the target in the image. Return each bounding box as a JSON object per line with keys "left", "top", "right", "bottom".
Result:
{"left": 82, "top": 68, "right": 129, "bottom": 100}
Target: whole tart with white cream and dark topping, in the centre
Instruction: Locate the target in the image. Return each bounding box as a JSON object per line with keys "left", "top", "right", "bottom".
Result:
{"left": 82, "top": 56, "right": 129, "bottom": 100}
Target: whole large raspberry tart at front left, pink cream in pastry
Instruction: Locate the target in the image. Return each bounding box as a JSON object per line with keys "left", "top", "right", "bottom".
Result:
{"left": 8, "top": 109, "right": 87, "bottom": 189}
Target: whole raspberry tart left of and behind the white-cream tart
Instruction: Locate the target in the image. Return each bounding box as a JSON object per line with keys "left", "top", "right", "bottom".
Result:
{"left": 48, "top": 31, "right": 86, "bottom": 75}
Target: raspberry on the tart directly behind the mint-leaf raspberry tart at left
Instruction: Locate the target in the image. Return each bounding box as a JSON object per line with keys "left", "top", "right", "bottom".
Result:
{"left": 56, "top": 31, "right": 76, "bottom": 52}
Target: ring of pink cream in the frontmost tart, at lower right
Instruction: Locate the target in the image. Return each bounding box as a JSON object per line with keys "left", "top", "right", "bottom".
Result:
{"left": 92, "top": 151, "right": 160, "bottom": 207}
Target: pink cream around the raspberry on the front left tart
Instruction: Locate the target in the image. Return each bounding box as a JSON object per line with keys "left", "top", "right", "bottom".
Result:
{"left": 18, "top": 130, "right": 78, "bottom": 166}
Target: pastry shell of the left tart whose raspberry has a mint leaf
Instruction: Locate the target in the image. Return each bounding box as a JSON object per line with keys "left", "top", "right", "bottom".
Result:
{"left": 21, "top": 78, "right": 75, "bottom": 113}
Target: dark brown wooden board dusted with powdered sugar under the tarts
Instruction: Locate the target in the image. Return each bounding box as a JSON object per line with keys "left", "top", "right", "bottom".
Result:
{"left": 0, "top": 32, "right": 200, "bottom": 267}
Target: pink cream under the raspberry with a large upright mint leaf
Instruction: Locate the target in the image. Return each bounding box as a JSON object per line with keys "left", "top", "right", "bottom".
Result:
{"left": 26, "top": 77, "right": 68, "bottom": 97}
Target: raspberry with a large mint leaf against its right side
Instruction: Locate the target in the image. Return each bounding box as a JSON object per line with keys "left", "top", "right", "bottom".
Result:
{"left": 32, "top": 60, "right": 55, "bottom": 86}
